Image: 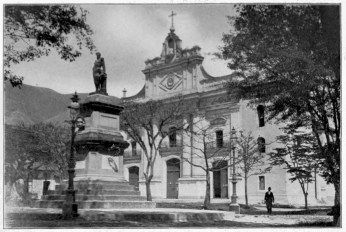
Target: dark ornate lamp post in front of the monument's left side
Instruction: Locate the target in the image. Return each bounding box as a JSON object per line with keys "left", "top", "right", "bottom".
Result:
{"left": 62, "top": 92, "right": 79, "bottom": 219}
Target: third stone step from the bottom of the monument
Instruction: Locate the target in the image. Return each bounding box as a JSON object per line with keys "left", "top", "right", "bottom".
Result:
{"left": 48, "top": 189, "right": 140, "bottom": 196}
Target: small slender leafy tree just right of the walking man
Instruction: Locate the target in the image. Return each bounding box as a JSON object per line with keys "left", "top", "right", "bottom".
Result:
{"left": 269, "top": 132, "right": 324, "bottom": 209}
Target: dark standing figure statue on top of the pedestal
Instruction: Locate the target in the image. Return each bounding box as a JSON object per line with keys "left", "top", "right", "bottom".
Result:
{"left": 93, "top": 52, "right": 107, "bottom": 94}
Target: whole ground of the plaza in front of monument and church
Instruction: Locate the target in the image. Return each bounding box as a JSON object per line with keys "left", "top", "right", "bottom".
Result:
{"left": 5, "top": 200, "right": 332, "bottom": 228}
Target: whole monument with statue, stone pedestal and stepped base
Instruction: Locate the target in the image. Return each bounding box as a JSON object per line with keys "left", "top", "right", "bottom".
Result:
{"left": 32, "top": 53, "right": 156, "bottom": 209}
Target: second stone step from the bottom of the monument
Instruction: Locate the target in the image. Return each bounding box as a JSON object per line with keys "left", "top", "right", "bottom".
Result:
{"left": 41, "top": 194, "right": 146, "bottom": 201}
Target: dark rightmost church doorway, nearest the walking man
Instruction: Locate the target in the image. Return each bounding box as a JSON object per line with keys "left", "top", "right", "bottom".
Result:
{"left": 213, "top": 161, "right": 228, "bottom": 198}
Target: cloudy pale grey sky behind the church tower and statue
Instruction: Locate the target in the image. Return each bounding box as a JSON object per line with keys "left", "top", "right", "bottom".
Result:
{"left": 11, "top": 4, "right": 239, "bottom": 97}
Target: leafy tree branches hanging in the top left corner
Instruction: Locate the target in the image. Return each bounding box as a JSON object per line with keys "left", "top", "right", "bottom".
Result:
{"left": 4, "top": 5, "right": 95, "bottom": 87}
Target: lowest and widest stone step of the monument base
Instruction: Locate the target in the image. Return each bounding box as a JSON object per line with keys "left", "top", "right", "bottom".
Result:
{"left": 31, "top": 200, "right": 156, "bottom": 209}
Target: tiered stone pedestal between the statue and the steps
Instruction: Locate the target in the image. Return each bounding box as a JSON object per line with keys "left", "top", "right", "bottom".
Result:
{"left": 75, "top": 94, "right": 129, "bottom": 181}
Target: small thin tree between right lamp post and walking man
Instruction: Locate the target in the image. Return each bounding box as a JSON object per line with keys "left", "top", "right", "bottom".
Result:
{"left": 236, "top": 131, "right": 271, "bottom": 207}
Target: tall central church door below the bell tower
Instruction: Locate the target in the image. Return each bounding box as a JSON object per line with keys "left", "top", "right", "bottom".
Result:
{"left": 167, "top": 158, "right": 180, "bottom": 198}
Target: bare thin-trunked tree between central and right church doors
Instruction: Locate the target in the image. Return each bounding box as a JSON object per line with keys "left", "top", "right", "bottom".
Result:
{"left": 183, "top": 120, "right": 231, "bottom": 209}
